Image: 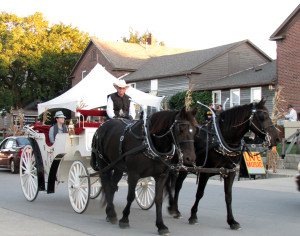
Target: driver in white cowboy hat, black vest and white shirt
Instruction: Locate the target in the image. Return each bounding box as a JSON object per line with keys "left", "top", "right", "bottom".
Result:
{"left": 106, "top": 79, "right": 135, "bottom": 120}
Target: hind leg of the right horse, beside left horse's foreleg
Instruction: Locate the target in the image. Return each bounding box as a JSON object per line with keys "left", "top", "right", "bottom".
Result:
{"left": 168, "top": 172, "right": 187, "bottom": 219}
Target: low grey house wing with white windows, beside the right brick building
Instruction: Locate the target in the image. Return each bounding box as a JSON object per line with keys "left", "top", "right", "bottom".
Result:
{"left": 198, "top": 60, "right": 277, "bottom": 113}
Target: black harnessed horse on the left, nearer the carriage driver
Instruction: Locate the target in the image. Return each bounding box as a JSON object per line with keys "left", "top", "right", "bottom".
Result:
{"left": 92, "top": 108, "right": 198, "bottom": 235}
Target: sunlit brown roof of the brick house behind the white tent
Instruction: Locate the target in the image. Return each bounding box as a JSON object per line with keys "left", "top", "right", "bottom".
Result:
{"left": 91, "top": 38, "right": 194, "bottom": 70}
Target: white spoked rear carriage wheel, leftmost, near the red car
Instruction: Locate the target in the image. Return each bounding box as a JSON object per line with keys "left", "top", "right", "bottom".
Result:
{"left": 20, "top": 145, "right": 39, "bottom": 202}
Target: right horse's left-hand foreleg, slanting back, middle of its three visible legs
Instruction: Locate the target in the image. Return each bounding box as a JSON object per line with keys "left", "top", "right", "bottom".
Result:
{"left": 189, "top": 173, "right": 210, "bottom": 225}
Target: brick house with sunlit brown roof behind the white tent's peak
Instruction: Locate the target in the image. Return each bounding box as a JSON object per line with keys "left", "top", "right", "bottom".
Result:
{"left": 70, "top": 38, "right": 192, "bottom": 86}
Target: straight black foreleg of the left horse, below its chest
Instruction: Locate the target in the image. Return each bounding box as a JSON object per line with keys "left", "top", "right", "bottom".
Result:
{"left": 155, "top": 174, "right": 170, "bottom": 235}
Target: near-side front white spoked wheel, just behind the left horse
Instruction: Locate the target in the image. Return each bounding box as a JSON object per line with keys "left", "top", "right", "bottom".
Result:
{"left": 68, "top": 161, "right": 90, "bottom": 214}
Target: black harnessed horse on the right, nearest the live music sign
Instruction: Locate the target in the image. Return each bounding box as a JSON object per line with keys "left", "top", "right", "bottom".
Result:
{"left": 168, "top": 99, "right": 279, "bottom": 229}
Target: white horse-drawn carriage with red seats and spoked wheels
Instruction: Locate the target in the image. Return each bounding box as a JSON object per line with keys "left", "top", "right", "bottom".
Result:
{"left": 20, "top": 110, "right": 155, "bottom": 213}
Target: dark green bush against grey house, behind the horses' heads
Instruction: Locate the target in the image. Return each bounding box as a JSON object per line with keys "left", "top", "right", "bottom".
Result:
{"left": 168, "top": 91, "right": 212, "bottom": 123}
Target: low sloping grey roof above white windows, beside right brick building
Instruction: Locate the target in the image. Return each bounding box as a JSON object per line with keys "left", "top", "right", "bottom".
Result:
{"left": 197, "top": 60, "right": 277, "bottom": 90}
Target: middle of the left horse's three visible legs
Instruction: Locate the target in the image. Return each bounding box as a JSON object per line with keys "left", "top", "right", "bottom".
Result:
{"left": 119, "top": 173, "right": 139, "bottom": 229}
